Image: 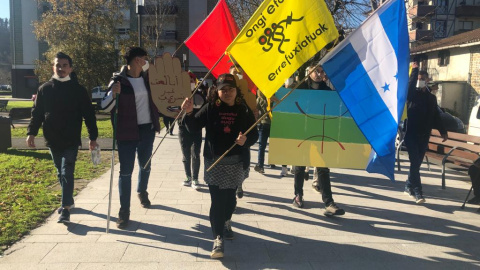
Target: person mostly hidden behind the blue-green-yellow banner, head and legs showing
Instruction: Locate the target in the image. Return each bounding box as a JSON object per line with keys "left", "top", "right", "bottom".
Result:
{"left": 293, "top": 65, "right": 345, "bottom": 216}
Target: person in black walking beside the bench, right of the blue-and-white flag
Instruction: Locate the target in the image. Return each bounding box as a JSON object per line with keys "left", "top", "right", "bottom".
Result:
{"left": 405, "top": 62, "right": 448, "bottom": 204}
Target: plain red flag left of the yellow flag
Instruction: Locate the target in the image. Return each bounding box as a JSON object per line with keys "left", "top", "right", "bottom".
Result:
{"left": 185, "top": 0, "right": 239, "bottom": 77}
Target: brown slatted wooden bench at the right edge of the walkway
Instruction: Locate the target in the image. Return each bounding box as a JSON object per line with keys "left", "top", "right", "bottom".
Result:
{"left": 425, "top": 130, "right": 480, "bottom": 189}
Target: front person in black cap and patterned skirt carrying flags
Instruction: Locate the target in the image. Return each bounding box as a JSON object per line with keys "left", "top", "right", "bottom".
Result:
{"left": 182, "top": 74, "right": 258, "bottom": 258}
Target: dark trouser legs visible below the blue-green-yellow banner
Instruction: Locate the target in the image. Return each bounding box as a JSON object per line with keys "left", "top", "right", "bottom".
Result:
{"left": 294, "top": 166, "right": 333, "bottom": 206}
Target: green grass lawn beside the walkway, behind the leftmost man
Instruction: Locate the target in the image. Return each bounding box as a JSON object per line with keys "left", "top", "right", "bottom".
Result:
{"left": 0, "top": 149, "right": 111, "bottom": 254}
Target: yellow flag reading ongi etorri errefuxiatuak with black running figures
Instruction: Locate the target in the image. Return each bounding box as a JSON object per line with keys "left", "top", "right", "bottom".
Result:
{"left": 227, "top": 0, "right": 338, "bottom": 98}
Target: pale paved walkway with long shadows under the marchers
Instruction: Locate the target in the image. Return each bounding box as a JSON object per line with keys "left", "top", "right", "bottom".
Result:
{"left": 0, "top": 134, "right": 480, "bottom": 270}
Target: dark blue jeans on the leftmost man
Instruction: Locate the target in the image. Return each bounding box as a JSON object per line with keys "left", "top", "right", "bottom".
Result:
{"left": 50, "top": 146, "right": 78, "bottom": 207}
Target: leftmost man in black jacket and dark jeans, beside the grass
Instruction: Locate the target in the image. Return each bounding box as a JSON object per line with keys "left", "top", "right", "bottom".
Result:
{"left": 27, "top": 52, "right": 98, "bottom": 223}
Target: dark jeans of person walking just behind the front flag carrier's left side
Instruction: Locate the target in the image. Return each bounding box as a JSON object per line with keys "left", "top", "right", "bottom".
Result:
{"left": 178, "top": 126, "right": 202, "bottom": 180}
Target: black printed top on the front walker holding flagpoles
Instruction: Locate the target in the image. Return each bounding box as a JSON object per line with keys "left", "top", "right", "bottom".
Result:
{"left": 183, "top": 100, "right": 258, "bottom": 161}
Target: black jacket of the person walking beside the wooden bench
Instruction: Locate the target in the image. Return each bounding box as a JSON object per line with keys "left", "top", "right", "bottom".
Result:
{"left": 407, "top": 68, "right": 447, "bottom": 136}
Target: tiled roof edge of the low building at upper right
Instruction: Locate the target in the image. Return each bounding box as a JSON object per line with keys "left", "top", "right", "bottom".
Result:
{"left": 410, "top": 28, "right": 480, "bottom": 54}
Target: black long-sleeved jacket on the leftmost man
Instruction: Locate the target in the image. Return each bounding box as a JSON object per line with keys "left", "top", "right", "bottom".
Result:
{"left": 27, "top": 78, "right": 98, "bottom": 149}
